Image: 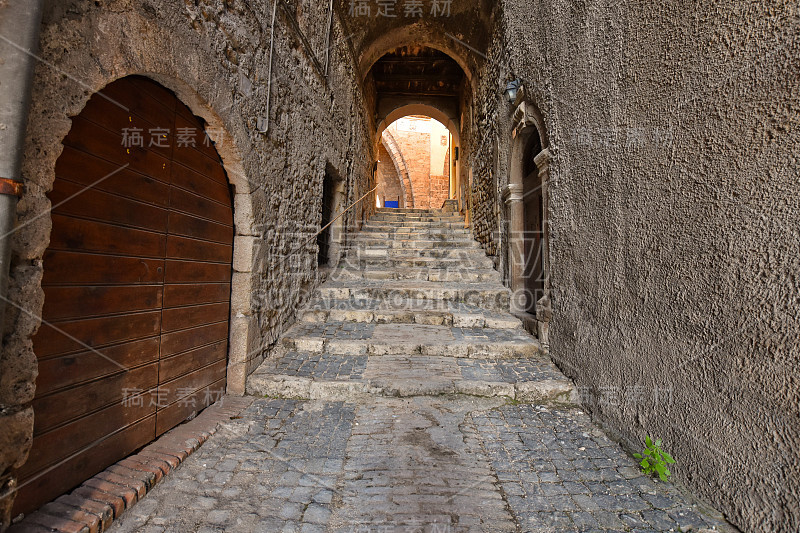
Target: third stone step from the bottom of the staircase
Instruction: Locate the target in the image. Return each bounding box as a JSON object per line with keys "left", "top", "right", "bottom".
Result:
{"left": 300, "top": 300, "right": 522, "bottom": 329}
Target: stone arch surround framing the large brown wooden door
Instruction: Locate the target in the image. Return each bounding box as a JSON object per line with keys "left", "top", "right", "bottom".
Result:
{"left": 11, "top": 8, "right": 264, "bottom": 400}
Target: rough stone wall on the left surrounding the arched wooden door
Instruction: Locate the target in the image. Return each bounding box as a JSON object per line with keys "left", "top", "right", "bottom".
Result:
{"left": 0, "top": 0, "right": 375, "bottom": 529}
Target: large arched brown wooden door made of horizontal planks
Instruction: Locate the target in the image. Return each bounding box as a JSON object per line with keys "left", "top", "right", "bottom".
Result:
{"left": 15, "top": 77, "right": 233, "bottom": 513}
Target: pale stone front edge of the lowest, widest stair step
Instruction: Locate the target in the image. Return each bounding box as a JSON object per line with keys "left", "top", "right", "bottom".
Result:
{"left": 247, "top": 374, "right": 580, "bottom": 407}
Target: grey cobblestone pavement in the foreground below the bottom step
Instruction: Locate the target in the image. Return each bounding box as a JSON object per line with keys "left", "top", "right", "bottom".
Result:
{"left": 111, "top": 397, "right": 727, "bottom": 533}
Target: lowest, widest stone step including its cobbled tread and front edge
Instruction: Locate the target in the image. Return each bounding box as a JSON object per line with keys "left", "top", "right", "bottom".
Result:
{"left": 247, "top": 351, "right": 578, "bottom": 406}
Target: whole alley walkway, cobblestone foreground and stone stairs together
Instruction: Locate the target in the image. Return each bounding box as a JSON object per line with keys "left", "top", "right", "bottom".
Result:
{"left": 111, "top": 210, "right": 726, "bottom": 533}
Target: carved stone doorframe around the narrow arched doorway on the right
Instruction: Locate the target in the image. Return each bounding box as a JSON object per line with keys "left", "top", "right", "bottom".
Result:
{"left": 502, "top": 101, "right": 553, "bottom": 350}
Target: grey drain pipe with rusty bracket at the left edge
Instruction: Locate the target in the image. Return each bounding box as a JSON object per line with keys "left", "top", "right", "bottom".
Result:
{"left": 0, "top": 0, "right": 44, "bottom": 330}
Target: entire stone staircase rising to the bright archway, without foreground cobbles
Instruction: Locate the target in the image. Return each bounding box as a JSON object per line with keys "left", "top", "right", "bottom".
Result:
{"left": 247, "top": 209, "right": 576, "bottom": 405}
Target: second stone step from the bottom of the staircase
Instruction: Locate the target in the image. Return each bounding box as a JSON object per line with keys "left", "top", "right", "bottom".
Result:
{"left": 281, "top": 322, "right": 540, "bottom": 359}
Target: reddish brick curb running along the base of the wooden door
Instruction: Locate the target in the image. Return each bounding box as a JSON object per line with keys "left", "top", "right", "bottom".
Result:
{"left": 7, "top": 396, "right": 254, "bottom": 533}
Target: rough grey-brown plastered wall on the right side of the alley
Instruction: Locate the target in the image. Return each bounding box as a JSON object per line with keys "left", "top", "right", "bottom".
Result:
{"left": 470, "top": 0, "right": 800, "bottom": 532}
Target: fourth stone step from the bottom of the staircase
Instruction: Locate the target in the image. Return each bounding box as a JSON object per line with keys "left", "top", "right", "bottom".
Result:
{"left": 314, "top": 280, "right": 511, "bottom": 311}
